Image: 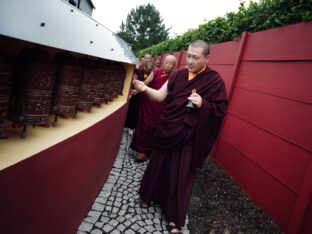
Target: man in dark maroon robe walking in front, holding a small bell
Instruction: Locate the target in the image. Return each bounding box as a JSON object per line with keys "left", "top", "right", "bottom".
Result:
{"left": 133, "top": 40, "right": 227, "bottom": 233}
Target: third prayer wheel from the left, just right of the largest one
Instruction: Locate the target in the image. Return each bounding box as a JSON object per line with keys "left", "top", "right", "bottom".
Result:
{"left": 52, "top": 53, "right": 81, "bottom": 119}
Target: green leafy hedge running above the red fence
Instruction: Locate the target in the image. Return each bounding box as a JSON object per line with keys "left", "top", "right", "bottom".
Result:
{"left": 136, "top": 0, "right": 312, "bottom": 57}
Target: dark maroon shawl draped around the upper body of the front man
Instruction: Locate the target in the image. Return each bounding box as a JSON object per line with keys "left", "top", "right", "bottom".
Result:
{"left": 155, "top": 67, "right": 227, "bottom": 169}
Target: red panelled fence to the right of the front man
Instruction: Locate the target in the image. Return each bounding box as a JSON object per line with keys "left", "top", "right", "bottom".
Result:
{"left": 211, "top": 22, "right": 312, "bottom": 233}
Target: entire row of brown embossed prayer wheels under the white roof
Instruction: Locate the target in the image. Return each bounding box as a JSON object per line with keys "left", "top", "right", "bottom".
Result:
{"left": 0, "top": 48, "right": 126, "bottom": 138}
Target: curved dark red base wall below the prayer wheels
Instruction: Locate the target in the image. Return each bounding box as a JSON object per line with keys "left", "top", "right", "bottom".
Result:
{"left": 0, "top": 105, "right": 127, "bottom": 234}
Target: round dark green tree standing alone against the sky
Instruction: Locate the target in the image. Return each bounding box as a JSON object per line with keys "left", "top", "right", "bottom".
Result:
{"left": 117, "top": 4, "right": 169, "bottom": 51}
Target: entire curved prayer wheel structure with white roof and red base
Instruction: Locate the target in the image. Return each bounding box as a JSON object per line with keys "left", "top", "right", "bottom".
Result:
{"left": 0, "top": 0, "right": 136, "bottom": 233}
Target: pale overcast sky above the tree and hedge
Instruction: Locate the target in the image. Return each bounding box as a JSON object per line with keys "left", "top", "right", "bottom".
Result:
{"left": 92, "top": 0, "right": 259, "bottom": 37}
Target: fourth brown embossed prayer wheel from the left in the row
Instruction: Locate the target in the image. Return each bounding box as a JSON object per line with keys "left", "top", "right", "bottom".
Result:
{"left": 77, "top": 58, "right": 97, "bottom": 112}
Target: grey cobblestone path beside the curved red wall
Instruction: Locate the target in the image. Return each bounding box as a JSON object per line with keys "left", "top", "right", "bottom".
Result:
{"left": 77, "top": 129, "right": 189, "bottom": 234}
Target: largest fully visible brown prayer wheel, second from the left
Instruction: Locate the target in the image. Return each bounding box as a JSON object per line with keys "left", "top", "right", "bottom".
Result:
{"left": 10, "top": 48, "right": 55, "bottom": 138}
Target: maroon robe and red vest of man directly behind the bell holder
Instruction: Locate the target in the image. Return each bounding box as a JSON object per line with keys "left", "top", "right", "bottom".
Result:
{"left": 130, "top": 69, "right": 169, "bottom": 156}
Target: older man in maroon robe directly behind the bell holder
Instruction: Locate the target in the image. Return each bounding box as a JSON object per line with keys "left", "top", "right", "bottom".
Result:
{"left": 130, "top": 55, "right": 177, "bottom": 162}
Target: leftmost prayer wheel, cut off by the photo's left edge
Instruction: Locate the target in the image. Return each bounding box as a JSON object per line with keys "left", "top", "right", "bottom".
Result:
{"left": 0, "top": 55, "right": 14, "bottom": 139}
